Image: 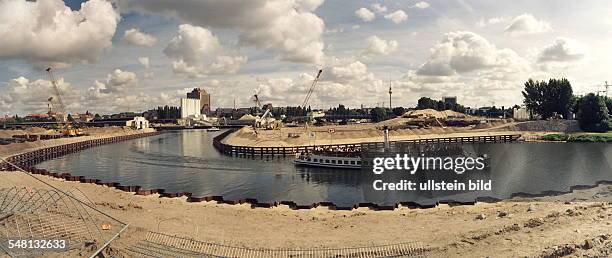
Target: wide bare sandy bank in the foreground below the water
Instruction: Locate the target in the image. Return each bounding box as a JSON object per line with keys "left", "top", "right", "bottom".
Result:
{"left": 0, "top": 172, "right": 612, "bottom": 257}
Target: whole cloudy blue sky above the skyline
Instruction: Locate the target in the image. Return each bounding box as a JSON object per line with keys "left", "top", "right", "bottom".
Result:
{"left": 0, "top": 0, "right": 612, "bottom": 115}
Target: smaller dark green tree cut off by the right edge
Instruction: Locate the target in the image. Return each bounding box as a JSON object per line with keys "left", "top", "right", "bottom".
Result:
{"left": 578, "top": 93, "right": 611, "bottom": 132}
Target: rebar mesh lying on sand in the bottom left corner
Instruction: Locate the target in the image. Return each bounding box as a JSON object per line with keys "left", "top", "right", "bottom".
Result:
{"left": 0, "top": 160, "right": 127, "bottom": 257}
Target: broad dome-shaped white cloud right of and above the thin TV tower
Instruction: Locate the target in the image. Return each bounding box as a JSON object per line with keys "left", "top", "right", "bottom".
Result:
{"left": 416, "top": 31, "right": 529, "bottom": 80}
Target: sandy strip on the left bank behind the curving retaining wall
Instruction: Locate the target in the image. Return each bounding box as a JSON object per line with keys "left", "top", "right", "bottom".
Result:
{"left": 0, "top": 126, "right": 154, "bottom": 157}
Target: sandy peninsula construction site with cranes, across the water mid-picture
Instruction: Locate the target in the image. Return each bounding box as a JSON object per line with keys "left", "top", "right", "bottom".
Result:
{"left": 223, "top": 70, "right": 580, "bottom": 147}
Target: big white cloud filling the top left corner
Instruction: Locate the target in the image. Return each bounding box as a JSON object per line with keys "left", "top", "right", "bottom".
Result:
{"left": 0, "top": 0, "right": 119, "bottom": 68}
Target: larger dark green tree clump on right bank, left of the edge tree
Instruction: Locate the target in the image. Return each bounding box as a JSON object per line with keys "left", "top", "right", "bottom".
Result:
{"left": 522, "top": 78, "right": 573, "bottom": 119}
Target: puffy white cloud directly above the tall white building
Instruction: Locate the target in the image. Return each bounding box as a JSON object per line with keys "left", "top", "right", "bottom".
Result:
{"left": 164, "top": 24, "right": 247, "bottom": 77}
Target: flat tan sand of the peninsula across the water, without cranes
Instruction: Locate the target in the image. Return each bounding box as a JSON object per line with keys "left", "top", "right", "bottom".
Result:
{"left": 223, "top": 118, "right": 559, "bottom": 147}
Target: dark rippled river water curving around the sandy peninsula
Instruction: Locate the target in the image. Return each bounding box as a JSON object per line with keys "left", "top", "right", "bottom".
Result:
{"left": 39, "top": 130, "right": 612, "bottom": 205}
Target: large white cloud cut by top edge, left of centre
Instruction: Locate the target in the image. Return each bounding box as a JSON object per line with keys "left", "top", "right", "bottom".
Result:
{"left": 117, "top": 0, "right": 325, "bottom": 63}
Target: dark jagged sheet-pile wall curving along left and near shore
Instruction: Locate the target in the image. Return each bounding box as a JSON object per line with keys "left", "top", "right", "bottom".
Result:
{"left": 0, "top": 132, "right": 612, "bottom": 211}
